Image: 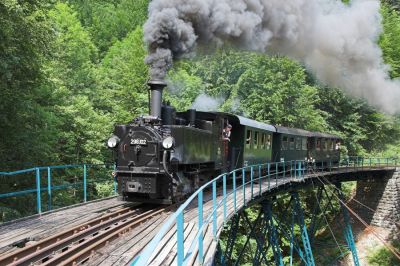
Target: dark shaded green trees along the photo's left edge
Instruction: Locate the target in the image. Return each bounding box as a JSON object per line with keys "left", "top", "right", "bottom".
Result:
{"left": 0, "top": 0, "right": 55, "bottom": 169}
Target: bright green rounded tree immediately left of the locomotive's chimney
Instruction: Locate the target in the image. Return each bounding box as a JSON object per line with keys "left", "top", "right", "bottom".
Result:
{"left": 94, "top": 27, "right": 149, "bottom": 123}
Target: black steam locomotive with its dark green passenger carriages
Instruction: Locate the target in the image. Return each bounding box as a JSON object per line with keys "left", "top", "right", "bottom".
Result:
{"left": 107, "top": 81, "right": 341, "bottom": 204}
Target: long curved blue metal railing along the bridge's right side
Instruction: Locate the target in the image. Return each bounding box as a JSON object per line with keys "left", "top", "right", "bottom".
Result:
{"left": 131, "top": 157, "right": 397, "bottom": 266}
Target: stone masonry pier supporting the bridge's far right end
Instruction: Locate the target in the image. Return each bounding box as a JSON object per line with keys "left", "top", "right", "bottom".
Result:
{"left": 351, "top": 168, "right": 400, "bottom": 233}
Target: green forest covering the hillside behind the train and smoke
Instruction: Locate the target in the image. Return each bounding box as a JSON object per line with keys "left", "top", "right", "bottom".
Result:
{"left": 0, "top": 0, "right": 400, "bottom": 264}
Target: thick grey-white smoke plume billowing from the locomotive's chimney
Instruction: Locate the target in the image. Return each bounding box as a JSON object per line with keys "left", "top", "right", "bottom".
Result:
{"left": 145, "top": 0, "right": 400, "bottom": 113}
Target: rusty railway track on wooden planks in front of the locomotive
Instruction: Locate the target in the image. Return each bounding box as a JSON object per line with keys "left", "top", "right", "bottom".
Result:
{"left": 0, "top": 205, "right": 172, "bottom": 266}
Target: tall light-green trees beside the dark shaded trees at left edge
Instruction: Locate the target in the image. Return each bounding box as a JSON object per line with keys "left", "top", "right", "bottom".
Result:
{"left": 46, "top": 3, "right": 112, "bottom": 163}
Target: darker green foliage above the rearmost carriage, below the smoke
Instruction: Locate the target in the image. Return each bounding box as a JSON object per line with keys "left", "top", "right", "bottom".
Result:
{"left": 318, "top": 88, "right": 400, "bottom": 155}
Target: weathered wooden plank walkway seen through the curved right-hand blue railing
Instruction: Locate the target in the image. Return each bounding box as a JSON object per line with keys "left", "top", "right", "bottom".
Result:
{"left": 141, "top": 167, "right": 395, "bottom": 265}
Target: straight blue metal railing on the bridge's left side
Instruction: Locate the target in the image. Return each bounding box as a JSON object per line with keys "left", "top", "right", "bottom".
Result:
{"left": 0, "top": 163, "right": 117, "bottom": 222}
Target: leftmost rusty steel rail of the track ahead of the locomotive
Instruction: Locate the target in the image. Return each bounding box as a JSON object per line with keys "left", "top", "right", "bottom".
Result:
{"left": 0, "top": 205, "right": 141, "bottom": 265}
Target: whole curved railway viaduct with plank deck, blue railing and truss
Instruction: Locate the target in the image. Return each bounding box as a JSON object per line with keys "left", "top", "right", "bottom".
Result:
{"left": 0, "top": 160, "right": 400, "bottom": 265}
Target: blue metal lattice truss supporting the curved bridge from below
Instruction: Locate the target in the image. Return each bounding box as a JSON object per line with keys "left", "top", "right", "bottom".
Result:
{"left": 215, "top": 185, "right": 359, "bottom": 266}
